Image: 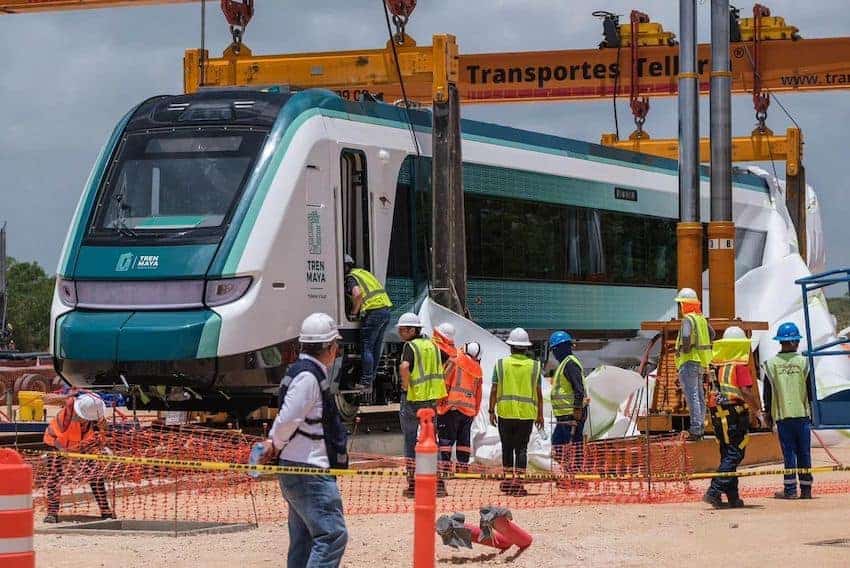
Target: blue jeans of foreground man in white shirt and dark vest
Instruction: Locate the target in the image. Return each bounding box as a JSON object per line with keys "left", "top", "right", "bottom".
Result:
{"left": 279, "top": 460, "right": 348, "bottom": 568}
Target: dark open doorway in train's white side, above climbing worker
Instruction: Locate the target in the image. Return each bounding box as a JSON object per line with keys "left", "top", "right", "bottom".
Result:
{"left": 340, "top": 149, "right": 372, "bottom": 270}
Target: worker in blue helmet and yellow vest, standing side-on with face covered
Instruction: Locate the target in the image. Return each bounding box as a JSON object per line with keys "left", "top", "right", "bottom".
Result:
{"left": 549, "top": 331, "right": 588, "bottom": 478}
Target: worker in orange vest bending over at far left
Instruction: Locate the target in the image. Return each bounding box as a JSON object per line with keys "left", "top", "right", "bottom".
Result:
{"left": 44, "top": 392, "right": 115, "bottom": 523}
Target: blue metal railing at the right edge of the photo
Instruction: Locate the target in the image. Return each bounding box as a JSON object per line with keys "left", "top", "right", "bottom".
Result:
{"left": 796, "top": 268, "right": 850, "bottom": 429}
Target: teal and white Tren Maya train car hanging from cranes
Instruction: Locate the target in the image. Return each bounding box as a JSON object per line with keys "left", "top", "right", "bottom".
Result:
{"left": 51, "top": 90, "right": 771, "bottom": 410}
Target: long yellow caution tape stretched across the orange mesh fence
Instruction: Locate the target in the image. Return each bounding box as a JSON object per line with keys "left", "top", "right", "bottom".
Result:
{"left": 57, "top": 452, "right": 850, "bottom": 481}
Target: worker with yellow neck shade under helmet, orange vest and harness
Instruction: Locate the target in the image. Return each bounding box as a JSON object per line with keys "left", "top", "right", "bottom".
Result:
{"left": 703, "top": 326, "right": 763, "bottom": 508}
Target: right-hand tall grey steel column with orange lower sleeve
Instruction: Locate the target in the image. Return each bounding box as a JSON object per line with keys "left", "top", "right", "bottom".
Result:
{"left": 708, "top": 0, "right": 735, "bottom": 319}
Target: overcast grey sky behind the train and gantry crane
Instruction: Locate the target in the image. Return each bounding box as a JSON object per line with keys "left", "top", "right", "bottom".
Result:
{"left": 0, "top": 0, "right": 850, "bottom": 273}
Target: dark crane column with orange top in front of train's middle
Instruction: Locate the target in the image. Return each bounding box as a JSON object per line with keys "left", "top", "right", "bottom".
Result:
{"left": 431, "top": 35, "right": 466, "bottom": 314}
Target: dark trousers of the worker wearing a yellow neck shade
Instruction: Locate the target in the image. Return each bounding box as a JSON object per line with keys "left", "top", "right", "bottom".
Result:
{"left": 708, "top": 404, "right": 750, "bottom": 499}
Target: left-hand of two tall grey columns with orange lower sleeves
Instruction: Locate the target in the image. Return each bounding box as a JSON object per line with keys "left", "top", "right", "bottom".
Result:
{"left": 676, "top": 0, "right": 703, "bottom": 298}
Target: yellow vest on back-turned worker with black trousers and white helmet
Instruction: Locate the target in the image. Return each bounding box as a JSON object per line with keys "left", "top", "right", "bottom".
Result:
{"left": 496, "top": 354, "right": 540, "bottom": 420}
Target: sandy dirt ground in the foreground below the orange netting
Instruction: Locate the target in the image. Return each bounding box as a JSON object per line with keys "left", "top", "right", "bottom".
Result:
{"left": 35, "top": 450, "right": 850, "bottom": 568}
